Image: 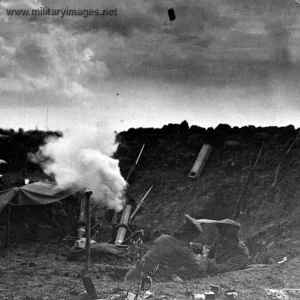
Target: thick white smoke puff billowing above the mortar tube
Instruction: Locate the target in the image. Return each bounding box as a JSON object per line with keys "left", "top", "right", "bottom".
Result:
{"left": 40, "top": 127, "right": 126, "bottom": 211}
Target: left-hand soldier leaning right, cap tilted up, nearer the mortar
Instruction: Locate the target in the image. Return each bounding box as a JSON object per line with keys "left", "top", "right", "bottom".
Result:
{"left": 125, "top": 215, "right": 209, "bottom": 281}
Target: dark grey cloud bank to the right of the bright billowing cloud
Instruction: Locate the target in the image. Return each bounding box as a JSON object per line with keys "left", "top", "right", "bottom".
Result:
{"left": 93, "top": 1, "right": 296, "bottom": 87}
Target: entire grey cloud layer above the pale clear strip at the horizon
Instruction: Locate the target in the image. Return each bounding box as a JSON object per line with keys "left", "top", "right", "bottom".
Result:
{"left": 0, "top": 0, "right": 300, "bottom": 112}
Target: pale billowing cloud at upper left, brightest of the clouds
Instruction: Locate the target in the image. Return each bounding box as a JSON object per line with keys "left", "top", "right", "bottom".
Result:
{"left": 0, "top": 5, "right": 109, "bottom": 105}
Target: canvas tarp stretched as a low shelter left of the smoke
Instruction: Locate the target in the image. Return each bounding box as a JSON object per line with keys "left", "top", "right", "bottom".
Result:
{"left": 0, "top": 181, "right": 74, "bottom": 212}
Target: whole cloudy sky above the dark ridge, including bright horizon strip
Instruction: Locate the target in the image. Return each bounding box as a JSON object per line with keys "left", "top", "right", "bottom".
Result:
{"left": 0, "top": 0, "right": 300, "bottom": 131}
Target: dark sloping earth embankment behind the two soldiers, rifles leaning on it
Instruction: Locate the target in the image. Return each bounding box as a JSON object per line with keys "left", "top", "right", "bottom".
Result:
{"left": 115, "top": 122, "right": 300, "bottom": 263}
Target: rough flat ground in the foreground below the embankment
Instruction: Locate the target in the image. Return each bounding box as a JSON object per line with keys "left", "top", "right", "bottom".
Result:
{"left": 0, "top": 240, "right": 300, "bottom": 300}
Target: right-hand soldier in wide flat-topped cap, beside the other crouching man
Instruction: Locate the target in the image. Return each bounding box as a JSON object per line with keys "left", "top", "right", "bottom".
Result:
{"left": 192, "top": 219, "right": 249, "bottom": 275}
